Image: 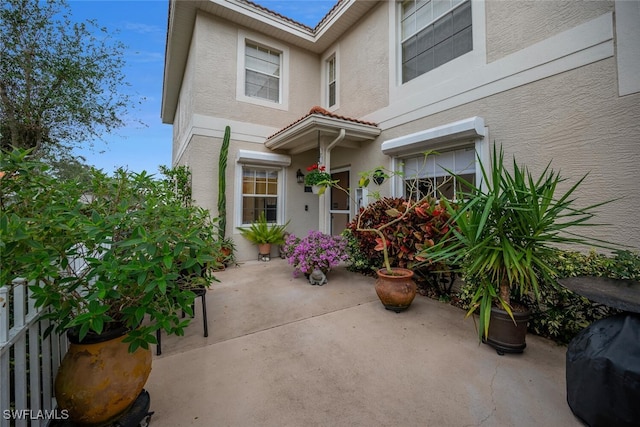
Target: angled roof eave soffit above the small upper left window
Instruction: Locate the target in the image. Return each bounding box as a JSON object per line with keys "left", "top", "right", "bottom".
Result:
{"left": 161, "top": 0, "right": 378, "bottom": 123}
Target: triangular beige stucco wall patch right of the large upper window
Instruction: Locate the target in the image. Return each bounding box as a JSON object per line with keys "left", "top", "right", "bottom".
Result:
{"left": 485, "top": 0, "right": 614, "bottom": 62}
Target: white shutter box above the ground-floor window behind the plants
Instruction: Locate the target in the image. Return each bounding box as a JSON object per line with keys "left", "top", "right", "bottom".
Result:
{"left": 382, "top": 116, "right": 485, "bottom": 156}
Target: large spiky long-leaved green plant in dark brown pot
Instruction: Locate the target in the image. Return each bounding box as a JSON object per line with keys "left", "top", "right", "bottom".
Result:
{"left": 423, "top": 145, "right": 606, "bottom": 354}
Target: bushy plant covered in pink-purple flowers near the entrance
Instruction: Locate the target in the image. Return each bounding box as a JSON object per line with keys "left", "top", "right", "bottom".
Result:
{"left": 283, "top": 231, "right": 349, "bottom": 277}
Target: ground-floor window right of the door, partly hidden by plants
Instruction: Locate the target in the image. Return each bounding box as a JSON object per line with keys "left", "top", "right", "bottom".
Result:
{"left": 403, "top": 146, "right": 476, "bottom": 200}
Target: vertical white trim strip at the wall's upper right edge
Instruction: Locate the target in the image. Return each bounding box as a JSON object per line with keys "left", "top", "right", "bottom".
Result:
{"left": 615, "top": 0, "right": 640, "bottom": 96}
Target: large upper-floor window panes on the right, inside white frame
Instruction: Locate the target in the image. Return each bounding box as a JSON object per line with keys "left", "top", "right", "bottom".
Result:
{"left": 400, "top": 0, "right": 473, "bottom": 83}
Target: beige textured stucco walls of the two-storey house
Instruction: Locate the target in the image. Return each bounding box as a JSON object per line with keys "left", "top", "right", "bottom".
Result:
{"left": 168, "top": 0, "right": 640, "bottom": 260}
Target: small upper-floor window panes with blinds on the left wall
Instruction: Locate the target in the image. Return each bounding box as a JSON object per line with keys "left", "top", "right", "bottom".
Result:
{"left": 244, "top": 42, "right": 281, "bottom": 102}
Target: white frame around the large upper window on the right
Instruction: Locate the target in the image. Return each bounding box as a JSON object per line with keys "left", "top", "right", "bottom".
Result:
{"left": 389, "top": 0, "right": 487, "bottom": 103}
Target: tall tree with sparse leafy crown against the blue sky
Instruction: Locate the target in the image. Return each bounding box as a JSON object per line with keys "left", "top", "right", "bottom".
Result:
{"left": 0, "top": 0, "right": 132, "bottom": 158}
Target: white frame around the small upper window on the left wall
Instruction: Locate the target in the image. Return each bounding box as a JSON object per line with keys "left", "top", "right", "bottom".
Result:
{"left": 236, "top": 29, "right": 290, "bottom": 110}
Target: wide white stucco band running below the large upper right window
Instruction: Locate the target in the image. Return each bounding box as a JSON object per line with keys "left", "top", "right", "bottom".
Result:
{"left": 376, "top": 12, "right": 614, "bottom": 130}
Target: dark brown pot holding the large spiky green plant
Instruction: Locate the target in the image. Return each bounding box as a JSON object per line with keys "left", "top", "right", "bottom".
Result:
{"left": 483, "top": 307, "right": 531, "bottom": 355}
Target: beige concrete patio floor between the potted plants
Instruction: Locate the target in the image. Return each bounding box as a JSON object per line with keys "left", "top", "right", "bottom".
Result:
{"left": 145, "top": 259, "right": 582, "bottom": 427}
